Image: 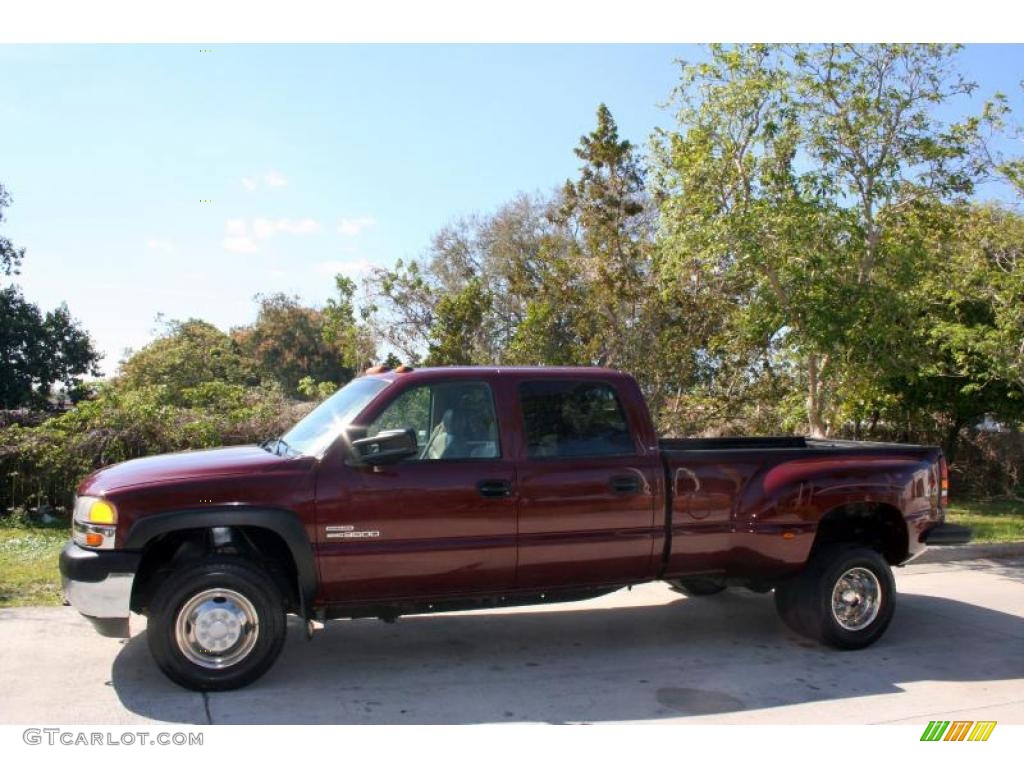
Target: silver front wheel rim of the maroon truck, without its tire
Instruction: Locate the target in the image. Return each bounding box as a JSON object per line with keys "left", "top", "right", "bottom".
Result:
{"left": 174, "top": 589, "right": 259, "bottom": 670}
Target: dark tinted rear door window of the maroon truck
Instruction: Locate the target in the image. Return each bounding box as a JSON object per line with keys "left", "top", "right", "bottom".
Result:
{"left": 519, "top": 381, "right": 636, "bottom": 459}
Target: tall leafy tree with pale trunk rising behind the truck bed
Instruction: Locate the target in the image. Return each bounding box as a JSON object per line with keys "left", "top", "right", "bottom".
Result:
{"left": 656, "top": 45, "right": 995, "bottom": 435}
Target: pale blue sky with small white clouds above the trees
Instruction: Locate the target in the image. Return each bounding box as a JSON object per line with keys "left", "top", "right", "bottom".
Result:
{"left": 0, "top": 45, "right": 1024, "bottom": 374}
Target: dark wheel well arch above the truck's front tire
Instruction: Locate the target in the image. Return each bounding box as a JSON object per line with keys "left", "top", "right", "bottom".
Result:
{"left": 131, "top": 525, "right": 301, "bottom": 612}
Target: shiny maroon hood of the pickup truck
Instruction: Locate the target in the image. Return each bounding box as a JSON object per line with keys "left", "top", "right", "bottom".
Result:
{"left": 78, "top": 445, "right": 290, "bottom": 496}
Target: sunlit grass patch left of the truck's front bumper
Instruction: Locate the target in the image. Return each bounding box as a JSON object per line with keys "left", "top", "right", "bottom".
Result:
{"left": 0, "top": 521, "right": 70, "bottom": 608}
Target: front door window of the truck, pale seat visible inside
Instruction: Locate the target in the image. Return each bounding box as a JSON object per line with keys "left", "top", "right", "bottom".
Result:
{"left": 367, "top": 381, "right": 501, "bottom": 460}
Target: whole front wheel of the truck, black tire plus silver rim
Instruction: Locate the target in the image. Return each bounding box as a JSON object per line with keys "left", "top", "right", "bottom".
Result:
{"left": 146, "top": 557, "right": 287, "bottom": 691}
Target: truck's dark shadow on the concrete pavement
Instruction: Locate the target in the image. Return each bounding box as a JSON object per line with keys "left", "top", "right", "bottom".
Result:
{"left": 113, "top": 590, "right": 1024, "bottom": 723}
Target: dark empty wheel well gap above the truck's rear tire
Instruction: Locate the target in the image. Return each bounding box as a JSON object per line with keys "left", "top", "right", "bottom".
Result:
{"left": 811, "top": 503, "right": 909, "bottom": 565}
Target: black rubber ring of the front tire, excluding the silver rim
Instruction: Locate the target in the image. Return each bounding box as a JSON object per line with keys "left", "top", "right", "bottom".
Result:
{"left": 146, "top": 558, "right": 287, "bottom": 690}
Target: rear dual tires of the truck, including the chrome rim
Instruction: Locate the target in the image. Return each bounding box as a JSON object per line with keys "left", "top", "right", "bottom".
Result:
{"left": 775, "top": 546, "right": 896, "bottom": 650}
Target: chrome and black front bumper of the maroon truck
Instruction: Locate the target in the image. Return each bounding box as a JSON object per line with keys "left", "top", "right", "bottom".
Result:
{"left": 60, "top": 542, "right": 141, "bottom": 637}
